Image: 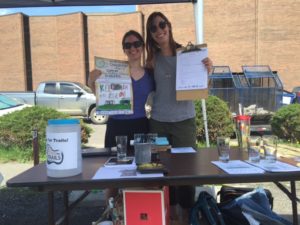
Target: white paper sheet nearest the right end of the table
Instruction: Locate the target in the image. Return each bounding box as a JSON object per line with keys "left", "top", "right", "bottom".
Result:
{"left": 246, "top": 160, "right": 300, "bottom": 172}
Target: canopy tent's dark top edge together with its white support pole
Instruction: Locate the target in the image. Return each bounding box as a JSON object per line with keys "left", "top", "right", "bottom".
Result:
{"left": 0, "top": 0, "right": 209, "bottom": 147}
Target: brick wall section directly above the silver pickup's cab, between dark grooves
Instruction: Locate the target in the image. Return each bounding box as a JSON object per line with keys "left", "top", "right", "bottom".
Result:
{"left": 30, "top": 13, "right": 85, "bottom": 89}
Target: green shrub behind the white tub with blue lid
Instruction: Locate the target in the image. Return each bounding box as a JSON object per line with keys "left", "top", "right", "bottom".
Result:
{"left": 0, "top": 106, "right": 92, "bottom": 161}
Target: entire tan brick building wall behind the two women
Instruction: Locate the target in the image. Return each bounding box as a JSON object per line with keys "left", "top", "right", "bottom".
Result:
{"left": 0, "top": 0, "right": 300, "bottom": 91}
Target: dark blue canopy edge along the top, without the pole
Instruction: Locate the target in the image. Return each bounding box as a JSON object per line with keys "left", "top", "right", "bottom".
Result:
{"left": 0, "top": 0, "right": 197, "bottom": 8}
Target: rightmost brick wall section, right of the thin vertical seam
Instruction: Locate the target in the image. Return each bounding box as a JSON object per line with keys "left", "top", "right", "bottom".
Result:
{"left": 257, "top": 0, "right": 300, "bottom": 90}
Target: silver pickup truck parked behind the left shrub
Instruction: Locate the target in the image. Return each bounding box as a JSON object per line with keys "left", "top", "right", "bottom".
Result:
{"left": 1, "top": 81, "right": 108, "bottom": 124}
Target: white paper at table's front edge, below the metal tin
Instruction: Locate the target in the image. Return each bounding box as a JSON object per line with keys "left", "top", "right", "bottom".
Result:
{"left": 92, "top": 167, "right": 164, "bottom": 180}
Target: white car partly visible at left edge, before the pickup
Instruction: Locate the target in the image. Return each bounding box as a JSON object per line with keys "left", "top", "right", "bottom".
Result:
{"left": 0, "top": 94, "right": 30, "bottom": 116}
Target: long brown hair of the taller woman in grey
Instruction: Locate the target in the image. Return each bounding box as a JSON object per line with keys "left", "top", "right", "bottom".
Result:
{"left": 146, "top": 12, "right": 178, "bottom": 69}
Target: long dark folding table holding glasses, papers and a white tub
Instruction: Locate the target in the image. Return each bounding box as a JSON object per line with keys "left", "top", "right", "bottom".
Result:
{"left": 7, "top": 148, "right": 300, "bottom": 225}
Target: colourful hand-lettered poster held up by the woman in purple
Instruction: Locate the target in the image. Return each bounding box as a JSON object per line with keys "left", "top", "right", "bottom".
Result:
{"left": 95, "top": 57, "right": 133, "bottom": 115}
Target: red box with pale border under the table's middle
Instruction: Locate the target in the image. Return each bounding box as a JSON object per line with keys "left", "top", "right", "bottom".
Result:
{"left": 123, "top": 187, "right": 169, "bottom": 225}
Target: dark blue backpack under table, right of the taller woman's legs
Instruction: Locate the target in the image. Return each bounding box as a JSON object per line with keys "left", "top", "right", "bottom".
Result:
{"left": 189, "top": 191, "right": 225, "bottom": 225}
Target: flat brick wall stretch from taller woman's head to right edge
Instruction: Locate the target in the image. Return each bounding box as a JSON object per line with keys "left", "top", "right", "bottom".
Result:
{"left": 138, "top": 0, "right": 300, "bottom": 90}
